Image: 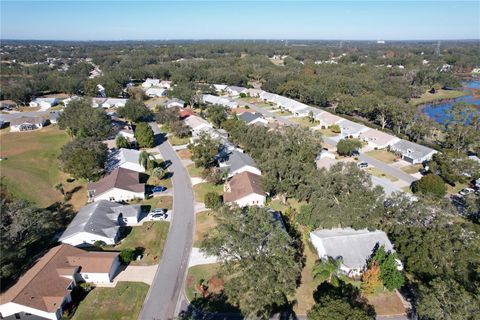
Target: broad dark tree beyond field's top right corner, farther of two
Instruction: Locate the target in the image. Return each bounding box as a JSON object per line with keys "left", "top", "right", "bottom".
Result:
{"left": 58, "top": 99, "right": 112, "bottom": 140}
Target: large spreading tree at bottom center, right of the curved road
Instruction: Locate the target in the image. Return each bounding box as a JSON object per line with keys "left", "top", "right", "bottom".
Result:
{"left": 201, "top": 206, "right": 301, "bottom": 318}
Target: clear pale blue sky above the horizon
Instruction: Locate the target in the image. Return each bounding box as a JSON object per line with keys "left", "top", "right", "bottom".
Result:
{"left": 0, "top": 0, "right": 480, "bottom": 40}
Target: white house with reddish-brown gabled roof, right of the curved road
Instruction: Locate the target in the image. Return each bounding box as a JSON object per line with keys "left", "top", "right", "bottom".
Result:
{"left": 223, "top": 171, "right": 266, "bottom": 207}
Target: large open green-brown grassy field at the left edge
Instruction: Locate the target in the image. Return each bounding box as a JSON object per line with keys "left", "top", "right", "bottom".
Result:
{"left": 0, "top": 126, "right": 73, "bottom": 207}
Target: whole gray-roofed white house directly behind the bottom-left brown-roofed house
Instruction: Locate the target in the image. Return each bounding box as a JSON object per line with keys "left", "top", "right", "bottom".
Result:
{"left": 58, "top": 200, "right": 142, "bottom": 246}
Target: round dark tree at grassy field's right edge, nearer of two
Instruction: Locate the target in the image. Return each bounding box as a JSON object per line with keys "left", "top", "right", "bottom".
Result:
{"left": 59, "top": 138, "right": 108, "bottom": 181}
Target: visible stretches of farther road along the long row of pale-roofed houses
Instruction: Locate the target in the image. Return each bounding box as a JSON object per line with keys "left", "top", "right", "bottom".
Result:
{"left": 241, "top": 102, "right": 417, "bottom": 185}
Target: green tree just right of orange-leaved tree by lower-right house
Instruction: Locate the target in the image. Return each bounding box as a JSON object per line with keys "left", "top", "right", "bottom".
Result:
{"left": 370, "top": 245, "right": 405, "bottom": 291}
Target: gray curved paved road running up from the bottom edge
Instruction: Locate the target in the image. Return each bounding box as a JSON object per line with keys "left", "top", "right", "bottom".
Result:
{"left": 139, "top": 123, "right": 195, "bottom": 320}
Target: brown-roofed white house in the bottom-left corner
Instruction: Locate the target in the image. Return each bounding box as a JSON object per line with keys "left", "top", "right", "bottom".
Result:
{"left": 0, "top": 244, "right": 120, "bottom": 320}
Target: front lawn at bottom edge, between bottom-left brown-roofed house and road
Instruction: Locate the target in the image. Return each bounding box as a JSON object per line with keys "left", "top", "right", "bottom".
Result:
{"left": 72, "top": 282, "right": 149, "bottom": 320}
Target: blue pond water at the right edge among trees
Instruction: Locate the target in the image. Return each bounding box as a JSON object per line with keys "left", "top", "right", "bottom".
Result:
{"left": 422, "top": 80, "right": 480, "bottom": 123}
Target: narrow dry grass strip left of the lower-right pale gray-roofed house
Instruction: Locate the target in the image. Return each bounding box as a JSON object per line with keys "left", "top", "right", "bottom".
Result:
{"left": 294, "top": 239, "right": 318, "bottom": 315}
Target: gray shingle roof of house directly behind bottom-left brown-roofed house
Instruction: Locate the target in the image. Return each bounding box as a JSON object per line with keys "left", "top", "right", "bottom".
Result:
{"left": 59, "top": 200, "right": 141, "bottom": 241}
